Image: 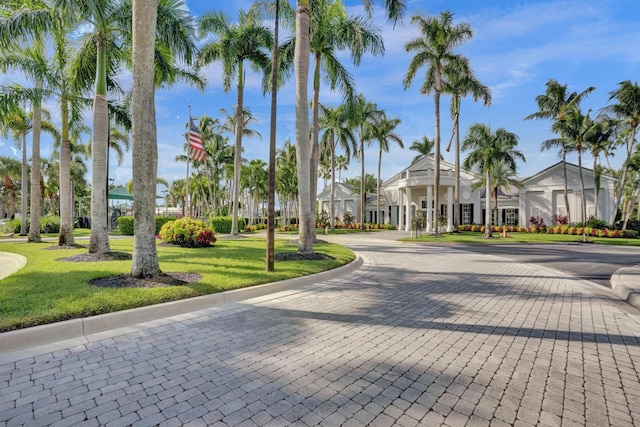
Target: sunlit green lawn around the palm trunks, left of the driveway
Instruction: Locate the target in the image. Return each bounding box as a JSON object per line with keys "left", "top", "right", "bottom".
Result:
{"left": 0, "top": 238, "right": 355, "bottom": 331}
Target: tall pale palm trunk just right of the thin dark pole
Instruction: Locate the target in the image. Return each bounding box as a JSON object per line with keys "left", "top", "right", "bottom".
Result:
{"left": 294, "top": 0, "right": 315, "bottom": 254}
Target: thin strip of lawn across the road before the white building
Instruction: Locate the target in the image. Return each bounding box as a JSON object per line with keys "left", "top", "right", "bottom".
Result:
{"left": 399, "top": 231, "right": 640, "bottom": 246}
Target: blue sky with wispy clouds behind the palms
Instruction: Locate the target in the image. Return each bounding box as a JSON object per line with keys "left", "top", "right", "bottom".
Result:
{"left": 0, "top": 0, "right": 640, "bottom": 192}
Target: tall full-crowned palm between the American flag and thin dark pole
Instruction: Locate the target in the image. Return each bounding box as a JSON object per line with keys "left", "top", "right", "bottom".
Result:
{"left": 198, "top": 11, "right": 273, "bottom": 235}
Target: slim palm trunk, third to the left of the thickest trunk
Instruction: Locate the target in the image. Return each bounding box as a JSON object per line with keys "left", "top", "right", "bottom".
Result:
{"left": 28, "top": 80, "right": 43, "bottom": 243}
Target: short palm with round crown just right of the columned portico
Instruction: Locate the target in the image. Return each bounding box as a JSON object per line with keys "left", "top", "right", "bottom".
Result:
{"left": 462, "top": 123, "right": 525, "bottom": 238}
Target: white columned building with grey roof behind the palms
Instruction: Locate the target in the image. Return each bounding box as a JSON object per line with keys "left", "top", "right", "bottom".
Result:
{"left": 318, "top": 155, "right": 616, "bottom": 231}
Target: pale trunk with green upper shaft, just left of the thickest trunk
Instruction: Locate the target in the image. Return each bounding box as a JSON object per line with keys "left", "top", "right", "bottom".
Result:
{"left": 88, "top": 38, "right": 109, "bottom": 253}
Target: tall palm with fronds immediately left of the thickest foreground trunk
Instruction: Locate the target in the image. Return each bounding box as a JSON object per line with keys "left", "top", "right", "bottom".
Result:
{"left": 54, "top": 0, "right": 202, "bottom": 256}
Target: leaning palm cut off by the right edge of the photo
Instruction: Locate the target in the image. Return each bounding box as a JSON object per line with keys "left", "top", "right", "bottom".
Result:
{"left": 604, "top": 80, "right": 640, "bottom": 224}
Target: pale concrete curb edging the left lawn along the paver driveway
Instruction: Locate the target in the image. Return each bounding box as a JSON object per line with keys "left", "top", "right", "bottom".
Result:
{"left": 0, "top": 257, "right": 364, "bottom": 356}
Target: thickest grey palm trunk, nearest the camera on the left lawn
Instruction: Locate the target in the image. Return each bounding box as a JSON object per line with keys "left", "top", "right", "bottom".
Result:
{"left": 131, "top": 0, "right": 160, "bottom": 278}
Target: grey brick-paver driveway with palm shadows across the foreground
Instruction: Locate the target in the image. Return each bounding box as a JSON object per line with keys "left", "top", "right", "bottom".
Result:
{"left": 0, "top": 237, "right": 640, "bottom": 427}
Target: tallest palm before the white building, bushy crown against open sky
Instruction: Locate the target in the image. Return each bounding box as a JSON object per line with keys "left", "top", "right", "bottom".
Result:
{"left": 403, "top": 11, "right": 472, "bottom": 234}
